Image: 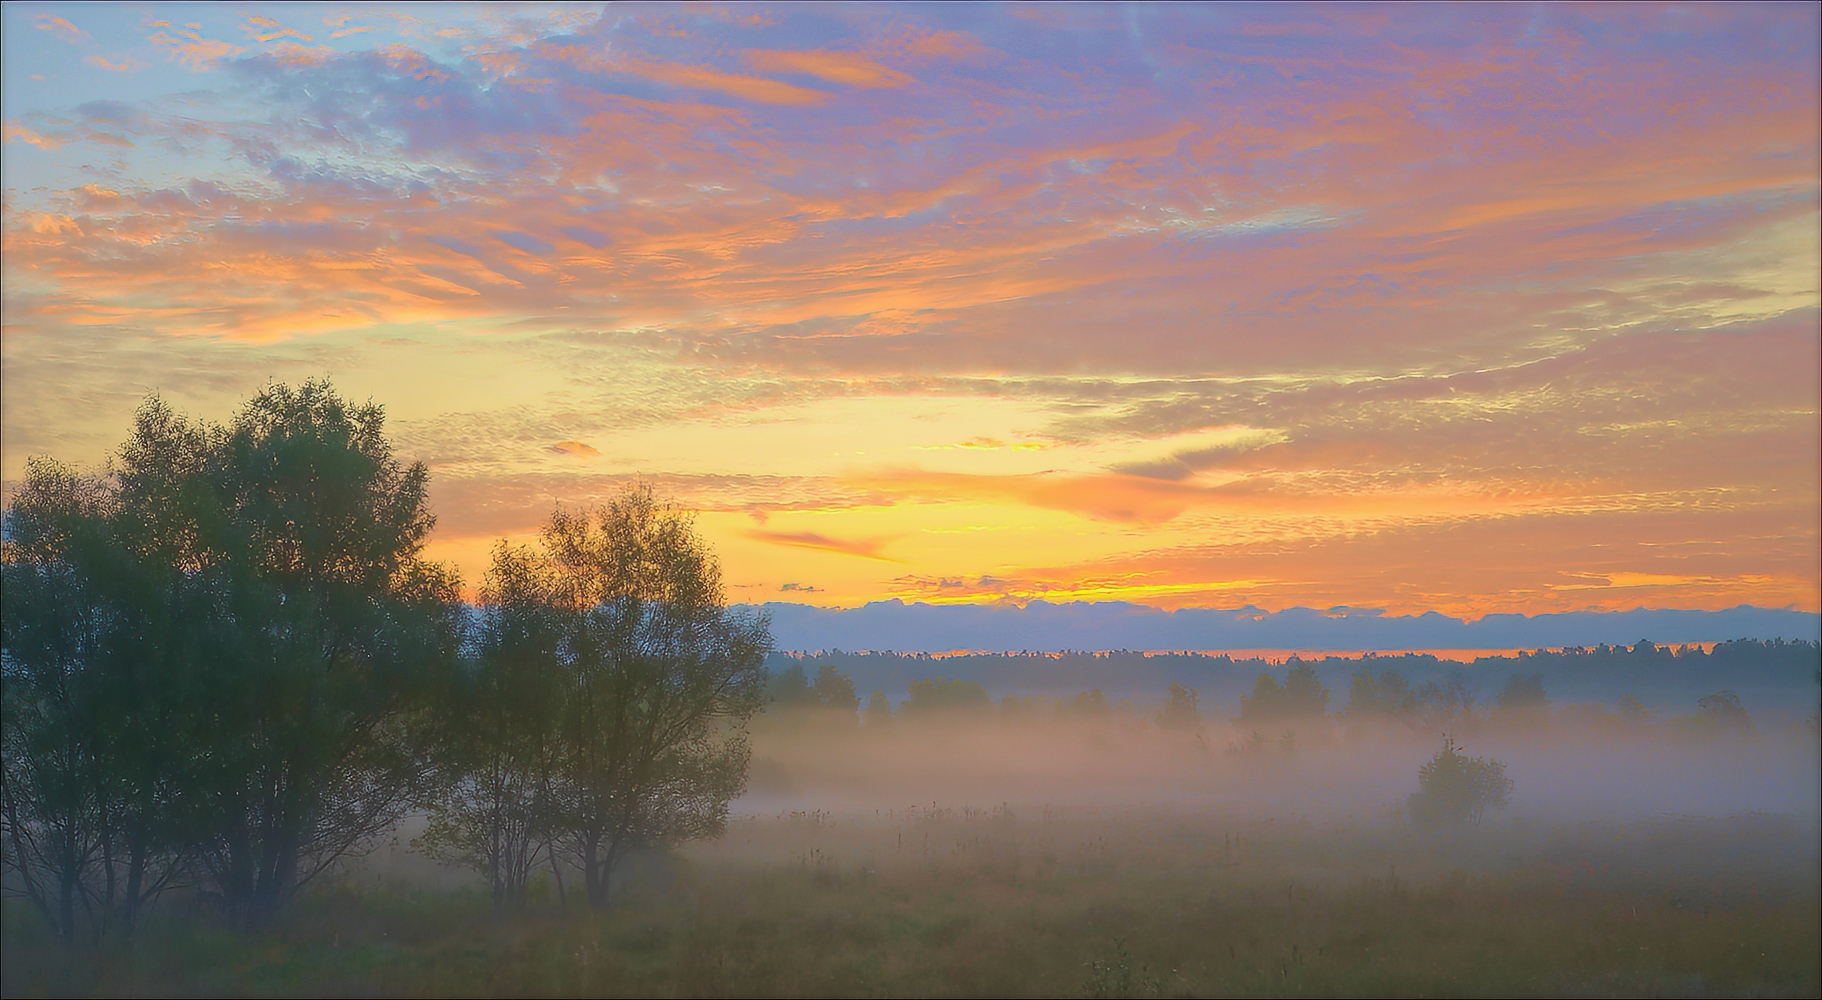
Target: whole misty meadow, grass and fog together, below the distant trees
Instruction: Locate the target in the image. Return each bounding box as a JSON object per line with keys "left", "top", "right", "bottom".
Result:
{"left": 4, "top": 712, "right": 1822, "bottom": 996}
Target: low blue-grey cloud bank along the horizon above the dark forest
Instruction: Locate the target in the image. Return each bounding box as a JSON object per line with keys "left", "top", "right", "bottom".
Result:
{"left": 745, "top": 599, "right": 1822, "bottom": 652}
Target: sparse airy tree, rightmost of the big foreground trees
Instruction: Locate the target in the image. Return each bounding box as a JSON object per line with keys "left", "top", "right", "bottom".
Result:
{"left": 536, "top": 486, "right": 771, "bottom": 909}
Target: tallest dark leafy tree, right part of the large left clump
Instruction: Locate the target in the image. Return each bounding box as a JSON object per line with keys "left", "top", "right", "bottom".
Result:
{"left": 195, "top": 383, "right": 459, "bottom": 923}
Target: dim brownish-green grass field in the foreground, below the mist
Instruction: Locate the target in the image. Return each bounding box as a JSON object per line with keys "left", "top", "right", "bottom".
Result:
{"left": 0, "top": 803, "right": 1822, "bottom": 996}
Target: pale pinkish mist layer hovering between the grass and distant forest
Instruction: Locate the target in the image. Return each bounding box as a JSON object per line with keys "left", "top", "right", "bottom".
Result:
{"left": 732, "top": 681, "right": 1818, "bottom": 823}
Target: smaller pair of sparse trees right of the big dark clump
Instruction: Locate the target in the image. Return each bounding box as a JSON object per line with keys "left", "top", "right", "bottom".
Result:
{"left": 426, "top": 486, "right": 771, "bottom": 907}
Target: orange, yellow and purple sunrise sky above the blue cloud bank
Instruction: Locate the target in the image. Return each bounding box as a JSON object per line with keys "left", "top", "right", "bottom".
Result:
{"left": 0, "top": 2, "right": 1822, "bottom": 619}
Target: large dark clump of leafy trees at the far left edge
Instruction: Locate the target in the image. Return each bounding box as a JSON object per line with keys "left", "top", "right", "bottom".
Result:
{"left": 4, "top": 383, "right": 457, "bottom": 934}
